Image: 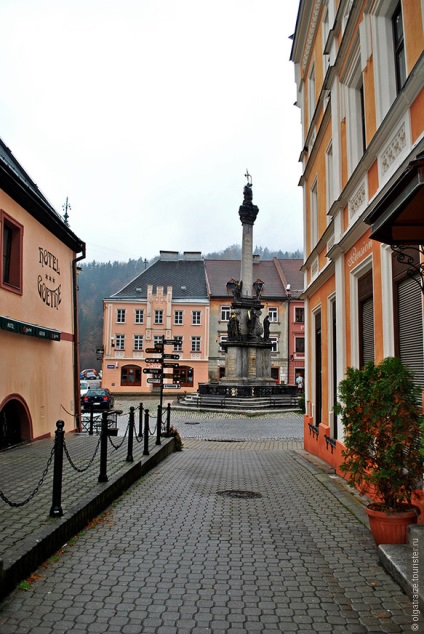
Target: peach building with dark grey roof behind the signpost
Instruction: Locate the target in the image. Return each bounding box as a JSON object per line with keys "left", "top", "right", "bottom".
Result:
{"left": 102, "top": 251, "right": 209, "bottom": 394}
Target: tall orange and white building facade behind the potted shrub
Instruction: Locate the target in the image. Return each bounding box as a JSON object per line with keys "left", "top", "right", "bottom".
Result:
{"left": 291, "top": 0, "right": 424, "bottom": 468}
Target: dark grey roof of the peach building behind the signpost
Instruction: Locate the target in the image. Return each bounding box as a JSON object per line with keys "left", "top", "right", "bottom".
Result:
{"left": 112, "top": 260, "right": 208, "bottom": 299}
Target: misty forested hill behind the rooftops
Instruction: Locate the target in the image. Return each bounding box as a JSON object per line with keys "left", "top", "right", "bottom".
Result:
{"left": 78, "top": 244, "right": 302, "bottom": 369}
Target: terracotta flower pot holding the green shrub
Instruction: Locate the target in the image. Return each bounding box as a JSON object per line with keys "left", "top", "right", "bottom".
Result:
{"left": 365, "top": 504, "right": 420, "bottom": 546}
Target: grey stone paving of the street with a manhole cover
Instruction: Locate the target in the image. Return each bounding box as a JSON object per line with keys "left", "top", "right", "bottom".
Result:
{"left": 0, "top": 402, "right": 424, "bottom": 634}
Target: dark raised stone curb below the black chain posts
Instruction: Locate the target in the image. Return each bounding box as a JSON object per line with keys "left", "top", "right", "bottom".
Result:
{"left": 0, "top": 437, "right": 175, "bottom": 598}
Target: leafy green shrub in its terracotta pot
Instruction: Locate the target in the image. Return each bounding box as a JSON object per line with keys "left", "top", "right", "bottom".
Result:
{"left": 336, "top": 357, "right": 424, "bottom": 545}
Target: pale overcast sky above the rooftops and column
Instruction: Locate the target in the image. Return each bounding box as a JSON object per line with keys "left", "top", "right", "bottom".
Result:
{"left": 0, "top": 0, "right": 303, "bottom": 261}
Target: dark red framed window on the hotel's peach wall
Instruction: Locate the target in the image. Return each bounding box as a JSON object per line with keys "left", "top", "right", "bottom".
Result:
{"left": 0, "top": 213, "right": 23, "bottom": 293}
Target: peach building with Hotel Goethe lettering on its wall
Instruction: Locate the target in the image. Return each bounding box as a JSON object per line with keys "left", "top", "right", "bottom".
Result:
{"left": 0, "top": 141, "right": 85, "bottom": 448}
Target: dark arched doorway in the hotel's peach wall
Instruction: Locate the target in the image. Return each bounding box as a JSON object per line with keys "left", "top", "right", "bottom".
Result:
{"left": 0, "top": 394, "right": 32, "bottom": 449}
